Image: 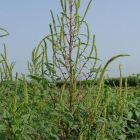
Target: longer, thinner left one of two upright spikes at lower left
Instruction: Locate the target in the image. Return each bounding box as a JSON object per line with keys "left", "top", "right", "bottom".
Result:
{"left": 13, "top": 72, "right": 18, "bottom": 113}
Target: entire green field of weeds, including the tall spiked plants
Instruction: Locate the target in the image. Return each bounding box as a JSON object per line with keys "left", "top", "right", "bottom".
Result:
{"left": 0, "top": 0, "right": 140, "bottom": 140}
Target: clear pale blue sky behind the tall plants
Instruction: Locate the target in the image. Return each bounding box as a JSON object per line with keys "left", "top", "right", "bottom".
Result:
{"left": 0, "top": 0, "right": 140, "bottom": 80}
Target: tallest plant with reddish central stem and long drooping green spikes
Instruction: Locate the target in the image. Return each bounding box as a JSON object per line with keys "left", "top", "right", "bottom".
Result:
{"left": 34, "top": 0, "right": 128, "bottom": 139}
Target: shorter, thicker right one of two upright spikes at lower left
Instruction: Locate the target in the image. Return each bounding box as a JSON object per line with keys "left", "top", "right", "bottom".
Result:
{"left": 23, "top": 74, "right": 28, "bottom": 105}
